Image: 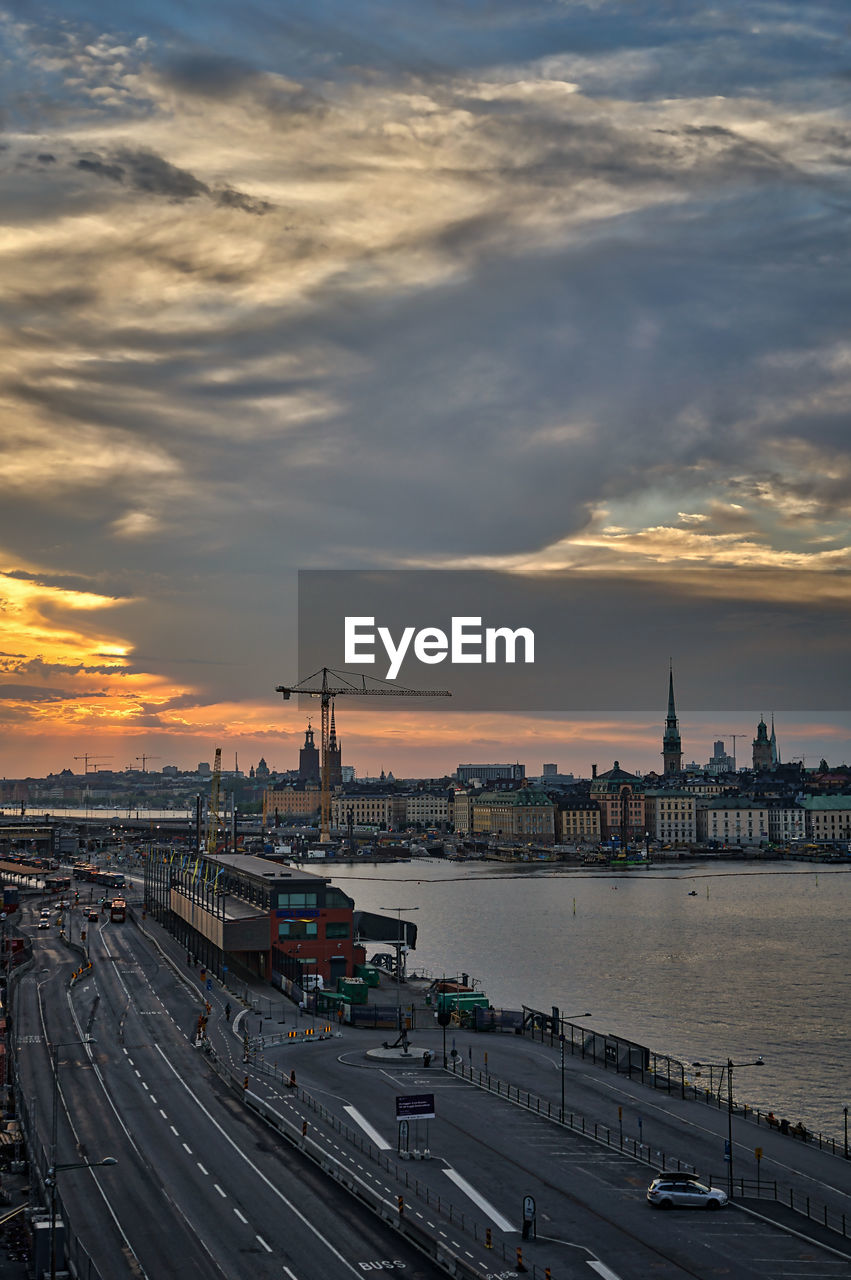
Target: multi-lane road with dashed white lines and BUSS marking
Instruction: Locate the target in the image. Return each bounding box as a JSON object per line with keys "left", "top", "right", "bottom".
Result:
{"left": 11, "top": 901, "right": 441, "bottom": 1280}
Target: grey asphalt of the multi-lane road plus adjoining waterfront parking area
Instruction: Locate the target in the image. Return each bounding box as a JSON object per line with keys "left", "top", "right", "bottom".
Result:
{"left": 8, "top": 890, "right": 851, "bottom": 1280}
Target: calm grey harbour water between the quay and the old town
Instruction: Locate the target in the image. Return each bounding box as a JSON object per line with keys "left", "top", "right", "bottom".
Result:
{"left": 330, "top": 859, "right": 851, "bottom": 1140}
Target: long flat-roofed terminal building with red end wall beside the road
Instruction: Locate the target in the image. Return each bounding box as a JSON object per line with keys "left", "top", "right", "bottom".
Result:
{"left": 145, "top": 851, "right": 365, "bottom": 987}
